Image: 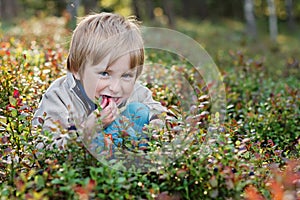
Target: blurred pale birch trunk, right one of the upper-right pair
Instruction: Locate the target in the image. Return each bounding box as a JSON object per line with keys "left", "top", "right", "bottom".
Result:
{"left": 267, "top": 0, "right": 278, "bottom": 41}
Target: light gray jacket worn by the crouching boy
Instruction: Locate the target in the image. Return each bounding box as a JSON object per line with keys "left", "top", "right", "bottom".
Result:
{"left": 32, "top": 72, "right": 167, "bottom": 130}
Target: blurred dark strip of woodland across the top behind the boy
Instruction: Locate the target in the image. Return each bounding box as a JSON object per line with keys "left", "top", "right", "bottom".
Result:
{"left": 0, "top": 0, "right": 300, "bottom": 33}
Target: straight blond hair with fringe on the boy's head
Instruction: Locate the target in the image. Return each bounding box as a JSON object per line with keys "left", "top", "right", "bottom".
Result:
{"left": 67, "top": 12, "right": 144, "bottom": 77}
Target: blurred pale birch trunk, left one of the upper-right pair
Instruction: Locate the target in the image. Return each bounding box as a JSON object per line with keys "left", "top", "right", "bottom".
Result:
{"left": 244, "top": 0, "right": 257, "bottom": 39}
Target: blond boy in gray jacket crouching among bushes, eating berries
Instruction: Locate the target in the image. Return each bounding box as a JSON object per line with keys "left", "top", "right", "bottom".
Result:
{"left": 32, "top": 13, "right": 167, "bottom": 153}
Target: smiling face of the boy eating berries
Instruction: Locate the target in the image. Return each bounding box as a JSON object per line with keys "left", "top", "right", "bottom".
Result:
{"left": 75, "top": 54, "right": 137, "bottom": 106}
